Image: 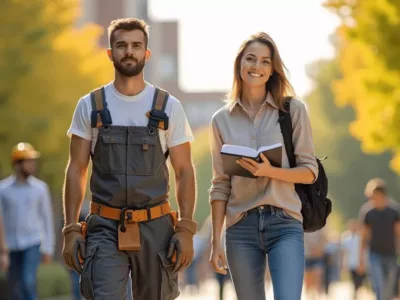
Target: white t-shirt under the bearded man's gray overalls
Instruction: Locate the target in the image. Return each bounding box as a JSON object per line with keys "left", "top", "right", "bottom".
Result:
{"left": 67, "top": 82, "right": 194, "bottom": 153}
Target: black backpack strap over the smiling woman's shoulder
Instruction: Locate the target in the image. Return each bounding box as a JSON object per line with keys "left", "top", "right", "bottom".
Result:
{"left": 278, "top": 98, "right": 296, "bottom": 168}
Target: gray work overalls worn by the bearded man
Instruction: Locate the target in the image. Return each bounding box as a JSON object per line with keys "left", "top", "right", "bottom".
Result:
{"left": 81, "top": 88, "right": 179, "bottom": 300}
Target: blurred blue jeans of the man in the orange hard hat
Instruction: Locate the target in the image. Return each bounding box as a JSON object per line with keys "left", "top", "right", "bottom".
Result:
{"left": 8, "top": 245, "right": 41, "bottom": 300}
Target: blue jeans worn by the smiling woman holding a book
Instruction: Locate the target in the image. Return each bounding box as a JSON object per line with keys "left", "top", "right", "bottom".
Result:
{"left": 225, "top": 206, "right": 304, "bottom": 300}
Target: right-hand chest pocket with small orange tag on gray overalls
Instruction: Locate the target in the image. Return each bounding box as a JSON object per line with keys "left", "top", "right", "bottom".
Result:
{"left": 127, "top": 134, "right": 163, "bottom": 176}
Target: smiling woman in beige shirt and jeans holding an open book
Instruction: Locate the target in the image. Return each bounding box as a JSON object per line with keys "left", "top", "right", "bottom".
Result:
{"left": 210, "top": 32, "right": 318, "bottom": 300}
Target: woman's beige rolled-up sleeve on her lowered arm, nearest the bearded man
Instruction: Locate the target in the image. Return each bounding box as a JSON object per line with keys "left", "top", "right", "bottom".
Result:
{"left": 209, "top": 118, "right": 231, "bottom": 204}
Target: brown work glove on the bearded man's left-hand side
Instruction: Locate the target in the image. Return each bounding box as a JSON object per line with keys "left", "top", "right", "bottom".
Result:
{"left": 62, "top": 223, "right": 86, "bottom": 274}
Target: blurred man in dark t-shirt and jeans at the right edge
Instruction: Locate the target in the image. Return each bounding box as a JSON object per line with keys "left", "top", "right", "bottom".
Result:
{"left": 358, "top": 178, "right": 400, "bottom": 300}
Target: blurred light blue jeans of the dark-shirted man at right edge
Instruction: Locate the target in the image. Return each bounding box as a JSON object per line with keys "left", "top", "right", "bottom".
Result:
{"left": 369, "top": 252, "right": 397, "bottom": 300}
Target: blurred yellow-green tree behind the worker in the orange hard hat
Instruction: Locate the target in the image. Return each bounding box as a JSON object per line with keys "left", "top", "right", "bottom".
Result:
{"left": 0, "top": 0, "right": 113, "bottom": 195}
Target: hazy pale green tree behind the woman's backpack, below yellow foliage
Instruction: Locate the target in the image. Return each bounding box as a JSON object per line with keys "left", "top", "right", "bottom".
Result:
{"left": 305, "top": 60, "right": 400, "bottom": 218}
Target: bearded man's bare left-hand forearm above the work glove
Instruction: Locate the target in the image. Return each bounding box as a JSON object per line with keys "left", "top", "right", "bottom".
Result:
{"left": 63, "top": 165, "right": 87, "bottom": 225}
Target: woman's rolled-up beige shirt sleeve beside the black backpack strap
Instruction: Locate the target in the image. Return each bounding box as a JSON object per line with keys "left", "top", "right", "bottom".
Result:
{"left": 290, "top": 100, "right": 318, "bottom": 181}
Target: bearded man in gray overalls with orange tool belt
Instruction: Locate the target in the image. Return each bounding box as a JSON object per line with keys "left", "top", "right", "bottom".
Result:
{"left": 63, "top": 18, "right": 197, "bottom": 300}
